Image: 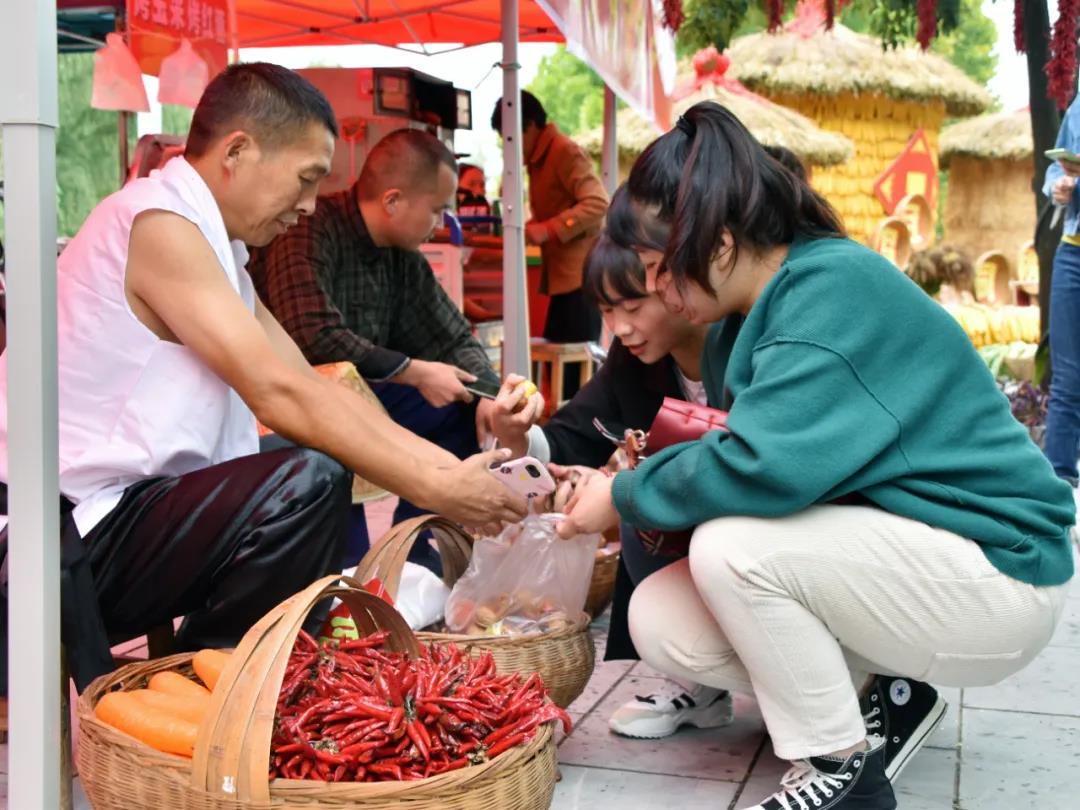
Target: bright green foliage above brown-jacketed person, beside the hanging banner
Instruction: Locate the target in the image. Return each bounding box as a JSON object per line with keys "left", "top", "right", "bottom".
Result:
{"left": 526, "top": 46, "right": 604, "bottom": 135}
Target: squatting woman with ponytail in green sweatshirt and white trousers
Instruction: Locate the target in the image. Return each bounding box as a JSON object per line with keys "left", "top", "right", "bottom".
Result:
{"left": 562, "top": 103, "right": 1075, "bottom": 810}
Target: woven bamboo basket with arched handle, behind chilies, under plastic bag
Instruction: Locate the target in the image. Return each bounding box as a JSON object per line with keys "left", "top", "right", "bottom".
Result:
{"left": 356, "top": 515, "right": 596, "bottom": 708}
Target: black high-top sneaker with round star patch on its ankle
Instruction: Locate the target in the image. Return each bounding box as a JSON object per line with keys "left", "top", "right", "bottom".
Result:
{"left": 860, "top": 675, "right": 946, "bottom": 782}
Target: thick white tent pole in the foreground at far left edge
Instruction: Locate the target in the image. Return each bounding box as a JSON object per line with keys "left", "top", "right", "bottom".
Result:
{"left": 0, "top": 0, "right": 60, "bottom": 810}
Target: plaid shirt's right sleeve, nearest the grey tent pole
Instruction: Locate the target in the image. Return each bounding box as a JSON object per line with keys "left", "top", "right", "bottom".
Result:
{"left": 390, "top": 252, "right": 499, "bottom": 382}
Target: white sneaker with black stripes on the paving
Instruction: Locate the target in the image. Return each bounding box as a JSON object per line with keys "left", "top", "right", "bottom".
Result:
{"left": 608, "top": 681, "right": 734, "bottom": 740}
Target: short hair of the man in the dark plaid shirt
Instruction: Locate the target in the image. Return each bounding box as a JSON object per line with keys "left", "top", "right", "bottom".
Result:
{"left": 356, "top": 129, "right": 458, "bottom": 200}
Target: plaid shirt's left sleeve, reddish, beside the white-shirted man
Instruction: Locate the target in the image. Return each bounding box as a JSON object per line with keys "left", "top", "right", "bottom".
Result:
{"left": 252, "top": 217, "right": 408, "bottom": 382}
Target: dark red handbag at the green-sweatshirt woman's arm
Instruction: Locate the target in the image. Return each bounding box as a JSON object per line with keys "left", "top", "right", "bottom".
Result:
{"left": 593, "top": 396, "right": 728, "bottom": 557}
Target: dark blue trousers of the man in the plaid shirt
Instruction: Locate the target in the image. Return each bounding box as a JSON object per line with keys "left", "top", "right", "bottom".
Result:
{"left": 372, "top": 382, "right": 480, "bottom": 576}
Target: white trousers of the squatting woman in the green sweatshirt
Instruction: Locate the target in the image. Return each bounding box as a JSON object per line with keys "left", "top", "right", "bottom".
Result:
{"left": 630, "top": 505, "right": 1068, "bottom": 759}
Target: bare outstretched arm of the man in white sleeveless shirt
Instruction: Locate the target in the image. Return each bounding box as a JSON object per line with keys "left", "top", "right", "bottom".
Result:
{"left": 126, "top": 211, "right": 525, "bottom": 526}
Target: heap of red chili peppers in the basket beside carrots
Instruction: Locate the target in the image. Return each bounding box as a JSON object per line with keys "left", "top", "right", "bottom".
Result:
{"left": 270, "top": 631, "right": 570, "bottom": 782}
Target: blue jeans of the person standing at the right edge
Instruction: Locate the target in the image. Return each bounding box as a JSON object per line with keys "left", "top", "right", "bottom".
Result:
{"left": 1044, "top": 242, "right": 1080, "bottom": 481}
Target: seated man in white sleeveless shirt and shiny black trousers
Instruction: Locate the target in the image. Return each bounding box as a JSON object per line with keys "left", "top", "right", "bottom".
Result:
{"left": 0, "top": 64, "right": 526, "bottom": 683}
